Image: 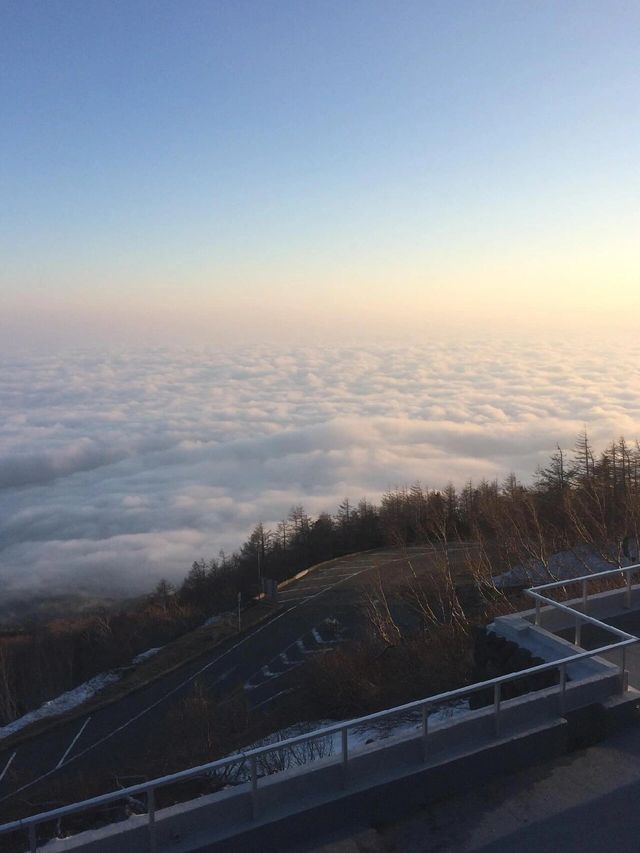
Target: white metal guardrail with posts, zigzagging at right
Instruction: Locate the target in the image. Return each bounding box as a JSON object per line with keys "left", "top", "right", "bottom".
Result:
{"left": 0, "top": 564, "right": 640, "bottom": 853}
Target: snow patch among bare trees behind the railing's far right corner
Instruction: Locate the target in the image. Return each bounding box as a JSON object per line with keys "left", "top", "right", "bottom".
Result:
{"left": 493, "top": 545, "right": 631, "bottom": 588}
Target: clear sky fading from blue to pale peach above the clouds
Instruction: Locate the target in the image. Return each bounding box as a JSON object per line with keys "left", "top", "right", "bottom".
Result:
{"left": 0, "top": 0, "right": 640, "bottom": 345}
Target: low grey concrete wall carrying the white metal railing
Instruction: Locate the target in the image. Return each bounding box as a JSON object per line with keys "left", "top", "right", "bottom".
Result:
{"left": 36, "top": 588, "right": 640, "bottom": 853}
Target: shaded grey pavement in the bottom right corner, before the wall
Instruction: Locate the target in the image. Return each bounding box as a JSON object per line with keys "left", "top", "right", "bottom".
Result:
{"left": 364, "top": 712, "right": 640, "bottom": 853}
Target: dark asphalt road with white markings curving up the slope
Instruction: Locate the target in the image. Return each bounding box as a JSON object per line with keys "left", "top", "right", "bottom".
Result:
{"left": 0, "top": 546, "right": 476, "bottom": 821}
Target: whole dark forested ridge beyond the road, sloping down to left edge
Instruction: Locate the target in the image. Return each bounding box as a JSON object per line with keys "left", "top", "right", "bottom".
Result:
{"left": 0, "top": 432, "right": 640, "bottom": 725}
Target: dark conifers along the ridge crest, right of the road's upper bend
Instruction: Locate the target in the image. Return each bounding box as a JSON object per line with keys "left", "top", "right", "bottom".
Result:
{"left": 174, "top": 431, "right": 640, "bottom": 607}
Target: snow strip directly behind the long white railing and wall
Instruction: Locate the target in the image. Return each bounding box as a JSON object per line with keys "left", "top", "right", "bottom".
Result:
{"left": 214, "top": 700, "right": 470, "bottom": 784}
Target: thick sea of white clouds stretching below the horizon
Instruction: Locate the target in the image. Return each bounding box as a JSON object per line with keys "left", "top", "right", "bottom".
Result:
{"left": 0, "top": 341, "right": 640, "bottom": 597}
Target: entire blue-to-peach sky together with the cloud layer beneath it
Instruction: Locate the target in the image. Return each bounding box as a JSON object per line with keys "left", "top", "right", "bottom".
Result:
{"left": 0, "top": 6, "right": 640, "bottom": 600}
